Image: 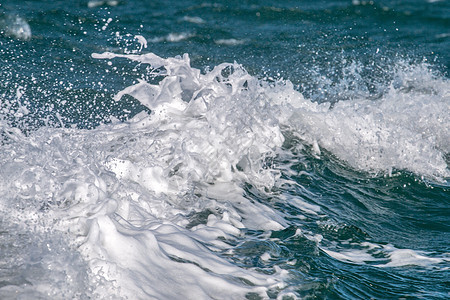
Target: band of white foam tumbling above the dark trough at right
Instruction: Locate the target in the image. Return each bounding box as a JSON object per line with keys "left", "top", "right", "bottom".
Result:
{"left": 290, "top": 65, "right": 450, "bottom": 179}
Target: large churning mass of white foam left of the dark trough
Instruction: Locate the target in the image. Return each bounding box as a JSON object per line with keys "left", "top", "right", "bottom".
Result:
{"left": 0, "top": 54, "right": 292, "bottom": 299}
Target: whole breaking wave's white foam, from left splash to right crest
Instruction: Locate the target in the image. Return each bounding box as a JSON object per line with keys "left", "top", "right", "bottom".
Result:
{"left": 0, "top": 53, "right": 450, "bottom": 299}
